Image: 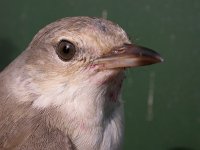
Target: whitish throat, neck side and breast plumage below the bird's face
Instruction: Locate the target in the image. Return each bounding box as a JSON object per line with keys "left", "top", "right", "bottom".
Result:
{"left": 3, "top": 66, "right": 123, "bottom": 150}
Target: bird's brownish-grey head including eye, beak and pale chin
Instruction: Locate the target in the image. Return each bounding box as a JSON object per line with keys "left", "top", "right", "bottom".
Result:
{"left": 4, "top": 17, "right": 162, "bottom": 107}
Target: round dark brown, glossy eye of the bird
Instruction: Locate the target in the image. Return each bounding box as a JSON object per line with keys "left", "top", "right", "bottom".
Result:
{"left": 56, "top": 40, "right": 76, "bottom": 61}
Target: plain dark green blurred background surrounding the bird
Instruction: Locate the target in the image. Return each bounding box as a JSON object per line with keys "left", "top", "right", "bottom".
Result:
{"left": 0, "top": 0, "right": 200, "bottom": 150}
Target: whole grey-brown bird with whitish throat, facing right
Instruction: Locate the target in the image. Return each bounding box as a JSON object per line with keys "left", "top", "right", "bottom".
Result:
{"left": 0, "top": 16, "right": 163, "bottom": 150}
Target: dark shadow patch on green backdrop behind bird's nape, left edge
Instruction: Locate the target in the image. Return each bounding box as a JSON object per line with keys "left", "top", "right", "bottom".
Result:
{"left": 0, "top": 37, "right": 19, "bottom": 71}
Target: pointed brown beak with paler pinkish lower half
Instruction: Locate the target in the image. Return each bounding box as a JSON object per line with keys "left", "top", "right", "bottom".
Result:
{"left": 94, "top": 44, "right": 163, "bottom": 69}
